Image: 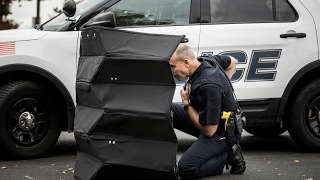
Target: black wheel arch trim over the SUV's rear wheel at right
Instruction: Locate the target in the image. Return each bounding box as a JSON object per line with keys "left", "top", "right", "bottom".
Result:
{"left": 277, "top": 60, "right": 320, "bottom": 121}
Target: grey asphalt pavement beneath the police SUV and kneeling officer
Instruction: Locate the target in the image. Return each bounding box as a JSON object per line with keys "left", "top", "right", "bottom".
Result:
{"left": 0, "top": 131, "right": 320, "bottom": 180}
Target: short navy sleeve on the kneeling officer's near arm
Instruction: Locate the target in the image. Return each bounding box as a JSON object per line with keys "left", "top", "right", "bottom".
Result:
{"left": 198, "top": 85, "right": 224, "bottom": 125}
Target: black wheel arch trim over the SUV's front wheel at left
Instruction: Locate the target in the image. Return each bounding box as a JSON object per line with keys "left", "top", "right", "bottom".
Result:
{"left": 0, "top": 64, "right": 75, "bottom": 131}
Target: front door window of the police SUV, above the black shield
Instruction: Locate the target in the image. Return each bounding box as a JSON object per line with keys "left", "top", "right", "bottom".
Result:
{"left": 107, "top": 0, "right": 191, "bottom": 27}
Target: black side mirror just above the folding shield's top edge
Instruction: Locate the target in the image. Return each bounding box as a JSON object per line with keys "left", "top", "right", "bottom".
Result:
{"left": 84, "top": 11, "right": 116, "bottom": 28}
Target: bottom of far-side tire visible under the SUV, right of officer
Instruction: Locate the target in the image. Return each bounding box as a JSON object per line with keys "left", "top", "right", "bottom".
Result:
{"left": 244, "top": 126, "right": 287, "bottom": 137}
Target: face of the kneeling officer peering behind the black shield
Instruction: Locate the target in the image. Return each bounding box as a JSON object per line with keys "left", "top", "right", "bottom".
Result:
{"left": 169, "top": 55, "right": 187, "bottom": 81}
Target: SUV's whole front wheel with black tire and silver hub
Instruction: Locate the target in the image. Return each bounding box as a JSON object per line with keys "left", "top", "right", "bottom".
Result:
{"left": 0, "top": 80, "right": 61, "bottom": 158}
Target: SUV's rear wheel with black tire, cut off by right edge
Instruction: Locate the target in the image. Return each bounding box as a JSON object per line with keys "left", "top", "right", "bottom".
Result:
{"left": 287, "top": 79, "right": 320, "bottom": 152}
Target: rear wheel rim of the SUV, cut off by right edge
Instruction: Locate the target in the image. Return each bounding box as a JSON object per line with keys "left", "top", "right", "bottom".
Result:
{"left": 307, "top": 96, "right": 320, "bottom": 138}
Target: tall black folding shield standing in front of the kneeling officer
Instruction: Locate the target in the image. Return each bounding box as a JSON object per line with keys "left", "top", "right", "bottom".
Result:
{"left": 74, "top": 26, "right": 184, "bottom": 179}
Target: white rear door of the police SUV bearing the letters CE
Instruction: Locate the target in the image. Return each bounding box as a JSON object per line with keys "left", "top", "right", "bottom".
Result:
{"left": 199, "top": 1, "right": 318, "bottom": 101}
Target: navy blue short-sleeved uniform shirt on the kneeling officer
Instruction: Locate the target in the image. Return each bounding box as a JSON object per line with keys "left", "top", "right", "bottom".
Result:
{"left": 188, "top": 55, "right": 236, "bottom": 125}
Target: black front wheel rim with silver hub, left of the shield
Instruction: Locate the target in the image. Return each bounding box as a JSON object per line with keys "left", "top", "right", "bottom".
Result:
{"left": 7, "top": 98, "right": 49, "bottom": 147}
